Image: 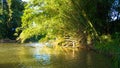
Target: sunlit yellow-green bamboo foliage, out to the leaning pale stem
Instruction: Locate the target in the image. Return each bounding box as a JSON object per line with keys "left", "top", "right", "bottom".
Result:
{"left": 20, "top": 0, "right": 97, "bottom": 45}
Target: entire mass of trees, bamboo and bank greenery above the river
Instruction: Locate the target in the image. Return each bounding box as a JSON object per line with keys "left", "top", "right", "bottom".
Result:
{"left": 0, "top": 0, "right": 120, "bottom": 68}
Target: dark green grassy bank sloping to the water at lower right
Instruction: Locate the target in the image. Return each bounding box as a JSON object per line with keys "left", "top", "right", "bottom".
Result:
{"left": 94, "top": 34, "right": 120, "bottom": 68}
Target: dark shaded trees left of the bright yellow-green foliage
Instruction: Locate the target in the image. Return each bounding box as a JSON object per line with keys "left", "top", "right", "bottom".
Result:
{"left": 0, "top": 0, "right": 24, "bottom": 39}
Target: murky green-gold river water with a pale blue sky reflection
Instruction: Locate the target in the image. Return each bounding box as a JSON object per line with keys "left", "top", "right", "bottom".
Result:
{"left": 0, "top": 43, "right": 112, "bottom": 68}
